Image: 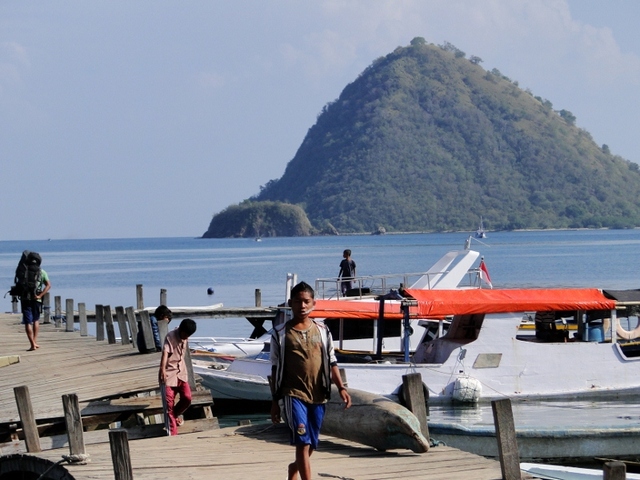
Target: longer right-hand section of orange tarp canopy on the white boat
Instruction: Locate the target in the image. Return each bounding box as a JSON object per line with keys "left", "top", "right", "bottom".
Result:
{"left": 407, "top": 288, "right": 616, "bottom": 317}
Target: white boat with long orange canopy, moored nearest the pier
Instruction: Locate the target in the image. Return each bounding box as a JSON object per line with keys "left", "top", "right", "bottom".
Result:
{"left": 199, "top": 289, "right": 640, "bottom": 402}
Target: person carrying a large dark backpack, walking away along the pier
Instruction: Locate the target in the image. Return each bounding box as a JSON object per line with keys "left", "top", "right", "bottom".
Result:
{"left": 14, "top": 250, "right": 51, "bottom": 352}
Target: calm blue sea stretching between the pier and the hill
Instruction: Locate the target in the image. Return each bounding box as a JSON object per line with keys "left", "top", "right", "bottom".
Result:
{"left": 0, "top": 230, "right": 640, "bottom": 336}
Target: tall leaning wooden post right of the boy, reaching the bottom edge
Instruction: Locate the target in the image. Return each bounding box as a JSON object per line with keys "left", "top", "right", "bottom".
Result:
{"left": 491, "top": 398, "right": 521, "bottom": 480}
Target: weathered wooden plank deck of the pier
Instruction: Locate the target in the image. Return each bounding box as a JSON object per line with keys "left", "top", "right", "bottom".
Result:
{"left": 0, "top": 314, "right": 528, "bottom": 480}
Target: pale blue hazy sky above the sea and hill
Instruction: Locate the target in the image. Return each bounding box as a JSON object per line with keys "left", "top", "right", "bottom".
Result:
{"left": 0, "top": 0, "right": 640, "bottom": 240}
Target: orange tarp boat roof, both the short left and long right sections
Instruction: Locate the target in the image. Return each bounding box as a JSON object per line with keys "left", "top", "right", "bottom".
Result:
{"left": 310, "top": 288, "right": 620, "bottom": 320}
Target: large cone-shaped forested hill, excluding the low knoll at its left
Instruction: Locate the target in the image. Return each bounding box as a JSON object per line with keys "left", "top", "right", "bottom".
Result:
{"left": 205, "top": 38, "right": 640, "bottom": 235}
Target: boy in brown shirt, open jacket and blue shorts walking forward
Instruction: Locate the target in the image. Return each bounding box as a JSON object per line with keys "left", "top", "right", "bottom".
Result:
{"left": 271, "top": 282, "right": 351, "bottom": 480}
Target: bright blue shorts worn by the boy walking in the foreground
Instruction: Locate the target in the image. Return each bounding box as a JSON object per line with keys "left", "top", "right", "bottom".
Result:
{"left": 284, "top": 395, "right": 325, "bottom": 450}
